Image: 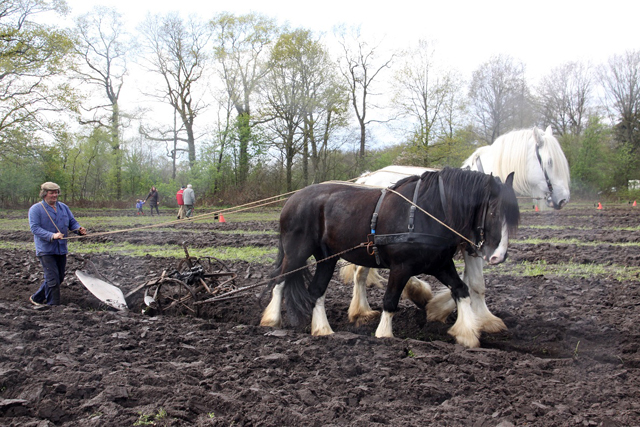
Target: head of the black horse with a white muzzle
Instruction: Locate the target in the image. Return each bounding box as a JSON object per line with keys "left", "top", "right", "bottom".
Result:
{"left": 476, "top": 172, "right": 520, "bottom": 264}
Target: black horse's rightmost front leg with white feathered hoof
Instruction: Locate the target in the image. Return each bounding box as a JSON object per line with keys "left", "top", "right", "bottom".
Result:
{"left": 436, "top": 259, "right": 480, "bottom": 347}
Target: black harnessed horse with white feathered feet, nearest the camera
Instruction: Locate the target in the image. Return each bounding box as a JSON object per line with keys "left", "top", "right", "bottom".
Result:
{"left": 260, "top": 168, "right": 519, "bottom": 347}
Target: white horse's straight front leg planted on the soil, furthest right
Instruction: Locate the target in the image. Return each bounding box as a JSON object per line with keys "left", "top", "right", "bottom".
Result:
{"left": 463, "top": 251, "right": 507, "bottom": 333}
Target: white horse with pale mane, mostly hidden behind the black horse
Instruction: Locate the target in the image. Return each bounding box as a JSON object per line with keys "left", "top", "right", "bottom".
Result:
{"left": 341, "top": 127, "right": 570, "bottom": 344}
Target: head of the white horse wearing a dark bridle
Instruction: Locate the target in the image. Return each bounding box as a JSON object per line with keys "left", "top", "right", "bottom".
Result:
{"left": 527, "top": 126, "right": 570, "bottom": 209}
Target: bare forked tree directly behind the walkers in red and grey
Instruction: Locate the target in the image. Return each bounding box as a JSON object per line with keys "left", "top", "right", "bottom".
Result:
{"left": 142, "top": 13, "right": 211, "bottom": 166}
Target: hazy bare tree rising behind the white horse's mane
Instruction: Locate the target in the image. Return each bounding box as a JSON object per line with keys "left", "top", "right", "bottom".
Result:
{"left": 469, "top": 55, "right": 528, "bottom": 144}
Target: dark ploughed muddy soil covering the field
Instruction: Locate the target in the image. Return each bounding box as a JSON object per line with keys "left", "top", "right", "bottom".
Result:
{"left": 0, "top": 205, "right": 640, "bottom": 427}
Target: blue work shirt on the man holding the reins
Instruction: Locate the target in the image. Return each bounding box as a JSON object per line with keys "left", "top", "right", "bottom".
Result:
{"left": 29, "top": 201, "right": 80, "bottom": 256}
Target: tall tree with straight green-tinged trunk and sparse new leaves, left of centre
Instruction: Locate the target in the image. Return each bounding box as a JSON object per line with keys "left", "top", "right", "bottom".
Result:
{"left": 210, "top": 13, "right": 280, "bottom": 184}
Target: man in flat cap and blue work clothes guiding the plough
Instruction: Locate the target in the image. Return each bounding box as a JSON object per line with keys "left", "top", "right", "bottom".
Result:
{"left": 29, "top": 182, "right": 87, "bottom": 306}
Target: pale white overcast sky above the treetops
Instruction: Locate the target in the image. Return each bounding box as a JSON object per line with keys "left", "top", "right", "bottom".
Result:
{"left": 68, "top": 0, "right": 640, "bottom": 79}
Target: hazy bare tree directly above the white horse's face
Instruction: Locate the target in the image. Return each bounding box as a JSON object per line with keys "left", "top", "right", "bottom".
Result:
{"left": 538, "top": 62, "right": 593, "bottom": 137}
